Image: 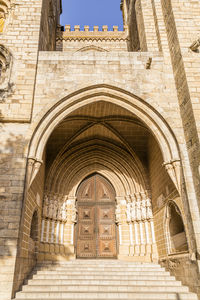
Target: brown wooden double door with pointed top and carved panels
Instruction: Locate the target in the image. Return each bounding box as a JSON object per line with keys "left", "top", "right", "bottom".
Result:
{"left": 76, "top": 174, "right": 117, "bottom": 258}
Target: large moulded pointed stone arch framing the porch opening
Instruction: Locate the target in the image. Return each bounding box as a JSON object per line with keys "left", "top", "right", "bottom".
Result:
{"left": 29, "top": 84, "right": 179, "bottom": 162}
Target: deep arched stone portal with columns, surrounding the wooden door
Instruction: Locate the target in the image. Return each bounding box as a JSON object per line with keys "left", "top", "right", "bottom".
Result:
{"left": 22, "top": 85, "right": 194, "bottom": 261}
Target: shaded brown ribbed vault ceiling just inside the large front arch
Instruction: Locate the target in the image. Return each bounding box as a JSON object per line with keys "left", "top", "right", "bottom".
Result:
{"left": 46, "top": 101, "right": 150, "bottom": 170}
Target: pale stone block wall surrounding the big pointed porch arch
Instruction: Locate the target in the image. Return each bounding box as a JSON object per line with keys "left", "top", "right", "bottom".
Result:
{"left": 0, "top": 0, "right": 200, "bottom": 300}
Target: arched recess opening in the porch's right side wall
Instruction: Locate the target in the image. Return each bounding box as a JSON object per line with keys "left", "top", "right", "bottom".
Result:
{"left": 166, "top": 201, "right": 188, "bottom": 254}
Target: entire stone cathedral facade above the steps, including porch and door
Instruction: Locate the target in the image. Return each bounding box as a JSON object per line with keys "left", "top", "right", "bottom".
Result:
{"left": 0, "top": 0, "right": 200, "bottom": 300}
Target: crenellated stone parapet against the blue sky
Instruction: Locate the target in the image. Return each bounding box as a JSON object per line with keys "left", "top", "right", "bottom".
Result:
{"left": 57, "top": 25, "right": 129, "bottom": 40}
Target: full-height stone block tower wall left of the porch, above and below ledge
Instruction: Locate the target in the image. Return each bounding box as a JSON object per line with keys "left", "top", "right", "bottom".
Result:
{"left": 0, "top": 0, "right": 42, "bottom": 300}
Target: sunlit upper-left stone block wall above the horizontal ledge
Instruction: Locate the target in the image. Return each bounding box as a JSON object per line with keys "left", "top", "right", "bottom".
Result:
{"left": 0, "top": 0, "right": 42, "bottom": 122}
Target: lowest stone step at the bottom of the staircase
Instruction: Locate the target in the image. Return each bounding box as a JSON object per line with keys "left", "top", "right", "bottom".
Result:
{"left": 16, "top": 291, "right": 198, "bottom": 300}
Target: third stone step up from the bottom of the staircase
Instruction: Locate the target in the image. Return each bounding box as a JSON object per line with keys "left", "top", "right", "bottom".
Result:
{"left": 27, "top": 277, "right": 181, "bottom": 286}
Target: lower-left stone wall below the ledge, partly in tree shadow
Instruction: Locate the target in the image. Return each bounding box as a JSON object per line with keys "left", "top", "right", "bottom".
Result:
{"left": 0, "top": 124, "right": 27, "bottom": 300}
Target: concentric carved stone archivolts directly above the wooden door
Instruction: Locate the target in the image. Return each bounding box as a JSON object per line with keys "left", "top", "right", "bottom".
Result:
{"left": 46, "top": 141, "right": 148, "bottom": 196}
